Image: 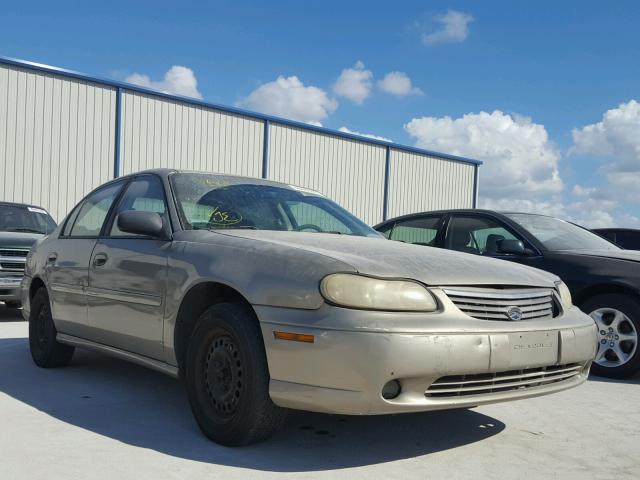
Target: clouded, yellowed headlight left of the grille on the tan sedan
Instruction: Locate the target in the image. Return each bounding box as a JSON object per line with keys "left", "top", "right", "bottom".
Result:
{"left": 320, "top": 273, "right": 438, "bottom": 312}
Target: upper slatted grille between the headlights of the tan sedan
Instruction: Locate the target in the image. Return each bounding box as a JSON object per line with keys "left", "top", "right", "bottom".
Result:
{"left": 444, "top": 288, "right": 557, "bottom": 321}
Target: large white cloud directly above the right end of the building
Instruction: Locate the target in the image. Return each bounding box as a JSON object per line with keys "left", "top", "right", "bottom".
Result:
{"left": 405, "top": 110, "right": 563, "bottom": 198}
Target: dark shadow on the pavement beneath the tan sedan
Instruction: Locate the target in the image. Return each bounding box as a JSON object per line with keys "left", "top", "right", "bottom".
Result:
{"left": 0, "top": 338, "right": 505, "bottom": 472}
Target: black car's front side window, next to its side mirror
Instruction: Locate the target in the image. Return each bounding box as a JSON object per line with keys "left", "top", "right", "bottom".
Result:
{"left": 446, "top": 216, "right": 521, "bottom": 256}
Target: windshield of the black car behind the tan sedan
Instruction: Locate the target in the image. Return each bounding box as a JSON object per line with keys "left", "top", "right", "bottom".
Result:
{"left": 506, "top": 213, "right": 619, "bottom": 251}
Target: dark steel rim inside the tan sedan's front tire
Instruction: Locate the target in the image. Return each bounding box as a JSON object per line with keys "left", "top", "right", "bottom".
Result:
{"left": 204, "top": 335, "right": 244, "bottom": 417}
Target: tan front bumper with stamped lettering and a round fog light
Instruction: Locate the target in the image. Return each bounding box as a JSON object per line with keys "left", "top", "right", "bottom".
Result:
{"left": 255, "top": 305, "right": 597, "bottom": 415}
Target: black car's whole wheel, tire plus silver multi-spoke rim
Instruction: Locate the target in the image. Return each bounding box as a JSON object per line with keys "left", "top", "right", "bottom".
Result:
{"left": 580, "top": 294, "right": 640, "bottom": 378}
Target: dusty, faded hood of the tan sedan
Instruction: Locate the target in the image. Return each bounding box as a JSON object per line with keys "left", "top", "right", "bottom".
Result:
{"left": 216, "top": 230, "right": 558, "bottom": 287}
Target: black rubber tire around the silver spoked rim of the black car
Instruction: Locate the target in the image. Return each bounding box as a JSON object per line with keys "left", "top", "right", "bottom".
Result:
{"left": 580, "top": 293, "right": 640, "bottom": 378}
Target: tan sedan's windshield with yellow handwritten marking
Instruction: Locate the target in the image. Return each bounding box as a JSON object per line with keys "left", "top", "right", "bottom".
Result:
{"left": 171, "top": 173, "right": 380, "bottom": 238}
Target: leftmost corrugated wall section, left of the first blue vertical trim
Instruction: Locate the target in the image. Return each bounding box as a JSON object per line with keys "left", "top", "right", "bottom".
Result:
{"left": 0, "top": 65, "right": 115, "bottom": 220}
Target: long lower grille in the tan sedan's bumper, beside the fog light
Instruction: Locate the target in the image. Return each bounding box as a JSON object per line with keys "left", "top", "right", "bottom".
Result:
{"left": 424, "top": 363, "right": 583, "bottom": 398}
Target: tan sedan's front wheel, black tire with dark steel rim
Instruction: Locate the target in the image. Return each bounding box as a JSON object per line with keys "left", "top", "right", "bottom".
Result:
{"left": 184, "top": 303, "right": 286, "bottom": 446}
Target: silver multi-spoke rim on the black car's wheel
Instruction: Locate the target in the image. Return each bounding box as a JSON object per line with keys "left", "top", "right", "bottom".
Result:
{"left": 589, "top": 307, "right": 638, "bottom": 368}
